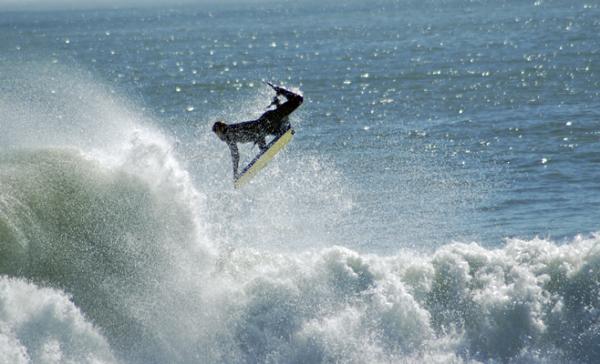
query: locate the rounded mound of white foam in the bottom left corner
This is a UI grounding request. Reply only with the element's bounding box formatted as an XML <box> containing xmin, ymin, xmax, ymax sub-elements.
<box><xmin>0</xmin><ymin>276</ymin><xmax>116</xmax><ymax>364</ymax></box>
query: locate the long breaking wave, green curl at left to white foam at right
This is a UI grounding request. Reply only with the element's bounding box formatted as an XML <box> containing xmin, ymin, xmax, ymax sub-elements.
<box><xmin>1</xmin><ymin>146</ymin><xmax>600</xmax><ymax>363</ymax></box>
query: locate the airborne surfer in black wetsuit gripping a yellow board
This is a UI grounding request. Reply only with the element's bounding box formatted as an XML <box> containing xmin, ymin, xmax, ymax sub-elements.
<box><xmin>212</xmin><ymin>82</ymin><xmax>304</xmax><ymax>180</ymax></box>
